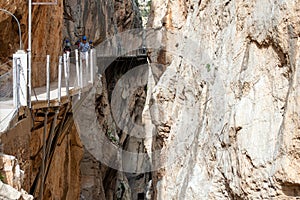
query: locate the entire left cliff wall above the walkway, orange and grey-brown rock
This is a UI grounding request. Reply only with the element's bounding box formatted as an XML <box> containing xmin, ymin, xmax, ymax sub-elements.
<box><xmin>0</xmin><ymin>0</ymin><xmax>141</xmax><ymax>87</ymax></box>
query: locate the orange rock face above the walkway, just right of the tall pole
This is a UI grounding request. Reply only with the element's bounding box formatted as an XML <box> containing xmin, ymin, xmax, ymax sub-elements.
<box><xmin>26</xmin><ymin>0</ymin><xmax>63</xmax><ymax>87</ymax></box>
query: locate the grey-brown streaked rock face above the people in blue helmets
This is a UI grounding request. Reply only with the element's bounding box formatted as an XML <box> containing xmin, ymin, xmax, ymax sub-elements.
<box><xmin>64</xmin><ymin>0</ymin><xmax>141</xmax><ymax>45</ymax></box>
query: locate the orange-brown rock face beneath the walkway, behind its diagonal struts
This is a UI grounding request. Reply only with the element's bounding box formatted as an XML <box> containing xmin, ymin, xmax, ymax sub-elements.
<box><xmin>29</xmin><ymin>108</ymin><xmax>83</xmax><ymax>199</ymax></box>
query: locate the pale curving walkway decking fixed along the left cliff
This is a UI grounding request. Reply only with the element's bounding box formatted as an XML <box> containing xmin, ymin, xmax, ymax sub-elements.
<box><xmin>0</xmin><ymin>50</ymin><xmax>147</xmax><ymax>133</ymax></box>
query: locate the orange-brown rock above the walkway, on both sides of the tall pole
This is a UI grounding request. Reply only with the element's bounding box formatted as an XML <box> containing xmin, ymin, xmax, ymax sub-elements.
<box><xmin>0</xmin><ymin>0</ymin><xmax>63</xmax><ymax>87</ymax></box>
